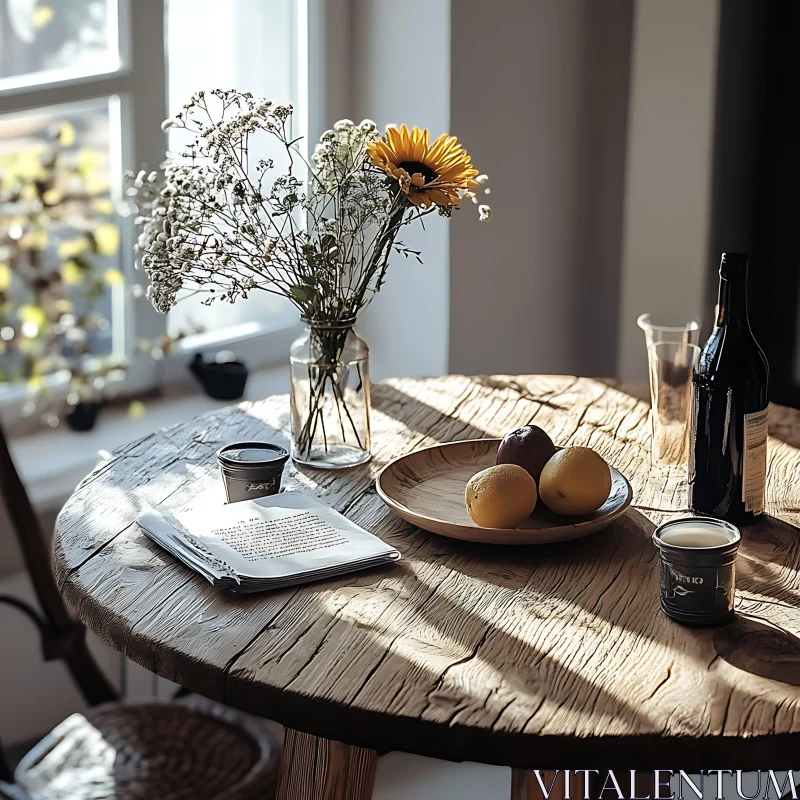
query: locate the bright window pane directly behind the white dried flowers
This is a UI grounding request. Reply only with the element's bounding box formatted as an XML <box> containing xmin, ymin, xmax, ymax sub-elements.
<box><xmin>167</xmin><ymin>0</ymin><xmax>297</xmax><ymax>335</ymax></box>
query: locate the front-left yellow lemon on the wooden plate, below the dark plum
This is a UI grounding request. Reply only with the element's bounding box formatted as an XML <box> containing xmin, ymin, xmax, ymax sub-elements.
<box><xmin>464</xmin><ymin>464</ymin><xmax>538</xmax><ymax>528</ymax></box>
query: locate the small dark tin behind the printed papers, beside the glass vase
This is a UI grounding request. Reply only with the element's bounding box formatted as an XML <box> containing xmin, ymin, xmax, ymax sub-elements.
<box><xmin>217</xmin><ymin>442</ymin><xmax>289</xmax><ymax>503</ymax></box>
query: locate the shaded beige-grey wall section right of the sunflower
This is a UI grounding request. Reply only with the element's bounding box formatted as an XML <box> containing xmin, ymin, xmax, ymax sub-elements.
<box><xmin>450</xmin><ymin>0</ymin><xmax>633</xmax><ymax>375</ymax></box>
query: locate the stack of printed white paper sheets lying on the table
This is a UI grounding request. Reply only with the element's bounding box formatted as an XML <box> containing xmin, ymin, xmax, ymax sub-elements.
<box><xmin>136</xmin><ymin>492</ymin><xmax>400</xmax><ymax>592</ymax></box>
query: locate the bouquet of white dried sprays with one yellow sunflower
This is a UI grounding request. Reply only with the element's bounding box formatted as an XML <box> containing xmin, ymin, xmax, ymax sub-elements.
<box><xmin>126</xmin><ymin>89</ymin><xmax>489</xmax><ymax>456</ymax></box>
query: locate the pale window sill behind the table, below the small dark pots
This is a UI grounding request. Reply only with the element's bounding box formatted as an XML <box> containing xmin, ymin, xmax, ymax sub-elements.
<box><xmin>9</xmin><ymin>365</ymin><xmax>289</xmax><ymax>512</ymax></box>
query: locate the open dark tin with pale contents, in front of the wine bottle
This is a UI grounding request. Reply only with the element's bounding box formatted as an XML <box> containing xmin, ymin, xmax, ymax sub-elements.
<box><xmin>653</xmin><ymin>517</ymin><xmax>742</xmax><ymax>625</ymax></box>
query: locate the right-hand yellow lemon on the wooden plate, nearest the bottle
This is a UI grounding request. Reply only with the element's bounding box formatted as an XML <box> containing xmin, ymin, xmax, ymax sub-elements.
<box><xmin>539</xmin><ymin>447</ymin><xmax>611</xmax><ymax>515</ymax></box>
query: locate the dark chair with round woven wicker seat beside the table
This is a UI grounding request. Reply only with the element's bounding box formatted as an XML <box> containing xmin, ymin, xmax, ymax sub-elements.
<box><xmin>0</xmin><ymin>428</ymin><xmax>279</xmax><ymax>800</ymax></box>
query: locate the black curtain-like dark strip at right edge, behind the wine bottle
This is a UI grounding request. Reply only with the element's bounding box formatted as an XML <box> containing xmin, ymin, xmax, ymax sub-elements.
<box><xmin>707</xmin><ymin>0</ymin><xmax>800</xmax><ymax>408</ymax></box>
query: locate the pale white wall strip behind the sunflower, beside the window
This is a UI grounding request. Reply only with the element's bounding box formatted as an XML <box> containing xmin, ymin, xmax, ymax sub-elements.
<box><xmin>351</xmin><ymin>0</ymin><xmax>450</xmax><ymax>380</ymax></box>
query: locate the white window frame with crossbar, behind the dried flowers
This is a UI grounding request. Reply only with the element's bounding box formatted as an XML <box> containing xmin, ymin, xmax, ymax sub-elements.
<box><xmin>0</xmin><ymin>0</ymin><xmax>310</xmax><ymax>418</ymax></box>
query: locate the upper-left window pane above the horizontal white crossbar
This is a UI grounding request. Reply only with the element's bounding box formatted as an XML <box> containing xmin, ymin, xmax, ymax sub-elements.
<box><xmin>0</xmin><ymin>0</ymin><xmax>119</xmax><ymax>89</ymax></box>
